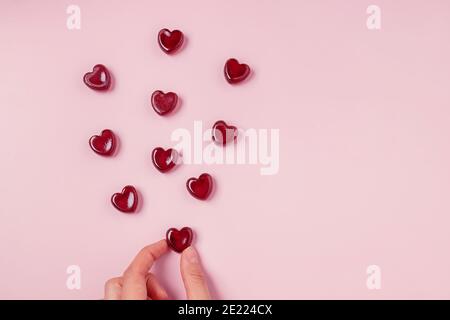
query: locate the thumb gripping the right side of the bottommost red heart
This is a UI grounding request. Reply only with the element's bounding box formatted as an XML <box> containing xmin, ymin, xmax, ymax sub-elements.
<box><xmin>180</xmin><ymin>247</ymin><xmax>211</xmax><ymax>300</ymax></box>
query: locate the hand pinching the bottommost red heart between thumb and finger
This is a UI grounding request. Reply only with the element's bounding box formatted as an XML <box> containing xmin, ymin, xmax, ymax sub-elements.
<box><xmin>105</xmin><ymin>240</ymin><xmax>211</xmax><ymax>300</ymax></box>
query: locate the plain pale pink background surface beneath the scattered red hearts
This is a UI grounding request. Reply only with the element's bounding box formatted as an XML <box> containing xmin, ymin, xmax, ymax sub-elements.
<box><xmin>0</xmin><ymin>0</ymin><xmax>450</xmax><ymax>299</ymax></box>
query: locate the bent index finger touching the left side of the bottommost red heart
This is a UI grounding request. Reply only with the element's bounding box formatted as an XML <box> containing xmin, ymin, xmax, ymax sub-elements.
<box><xmin>122</xmin><ymin>240</ymin><xmax>169</xmax><ymax>299</ymax></box>
